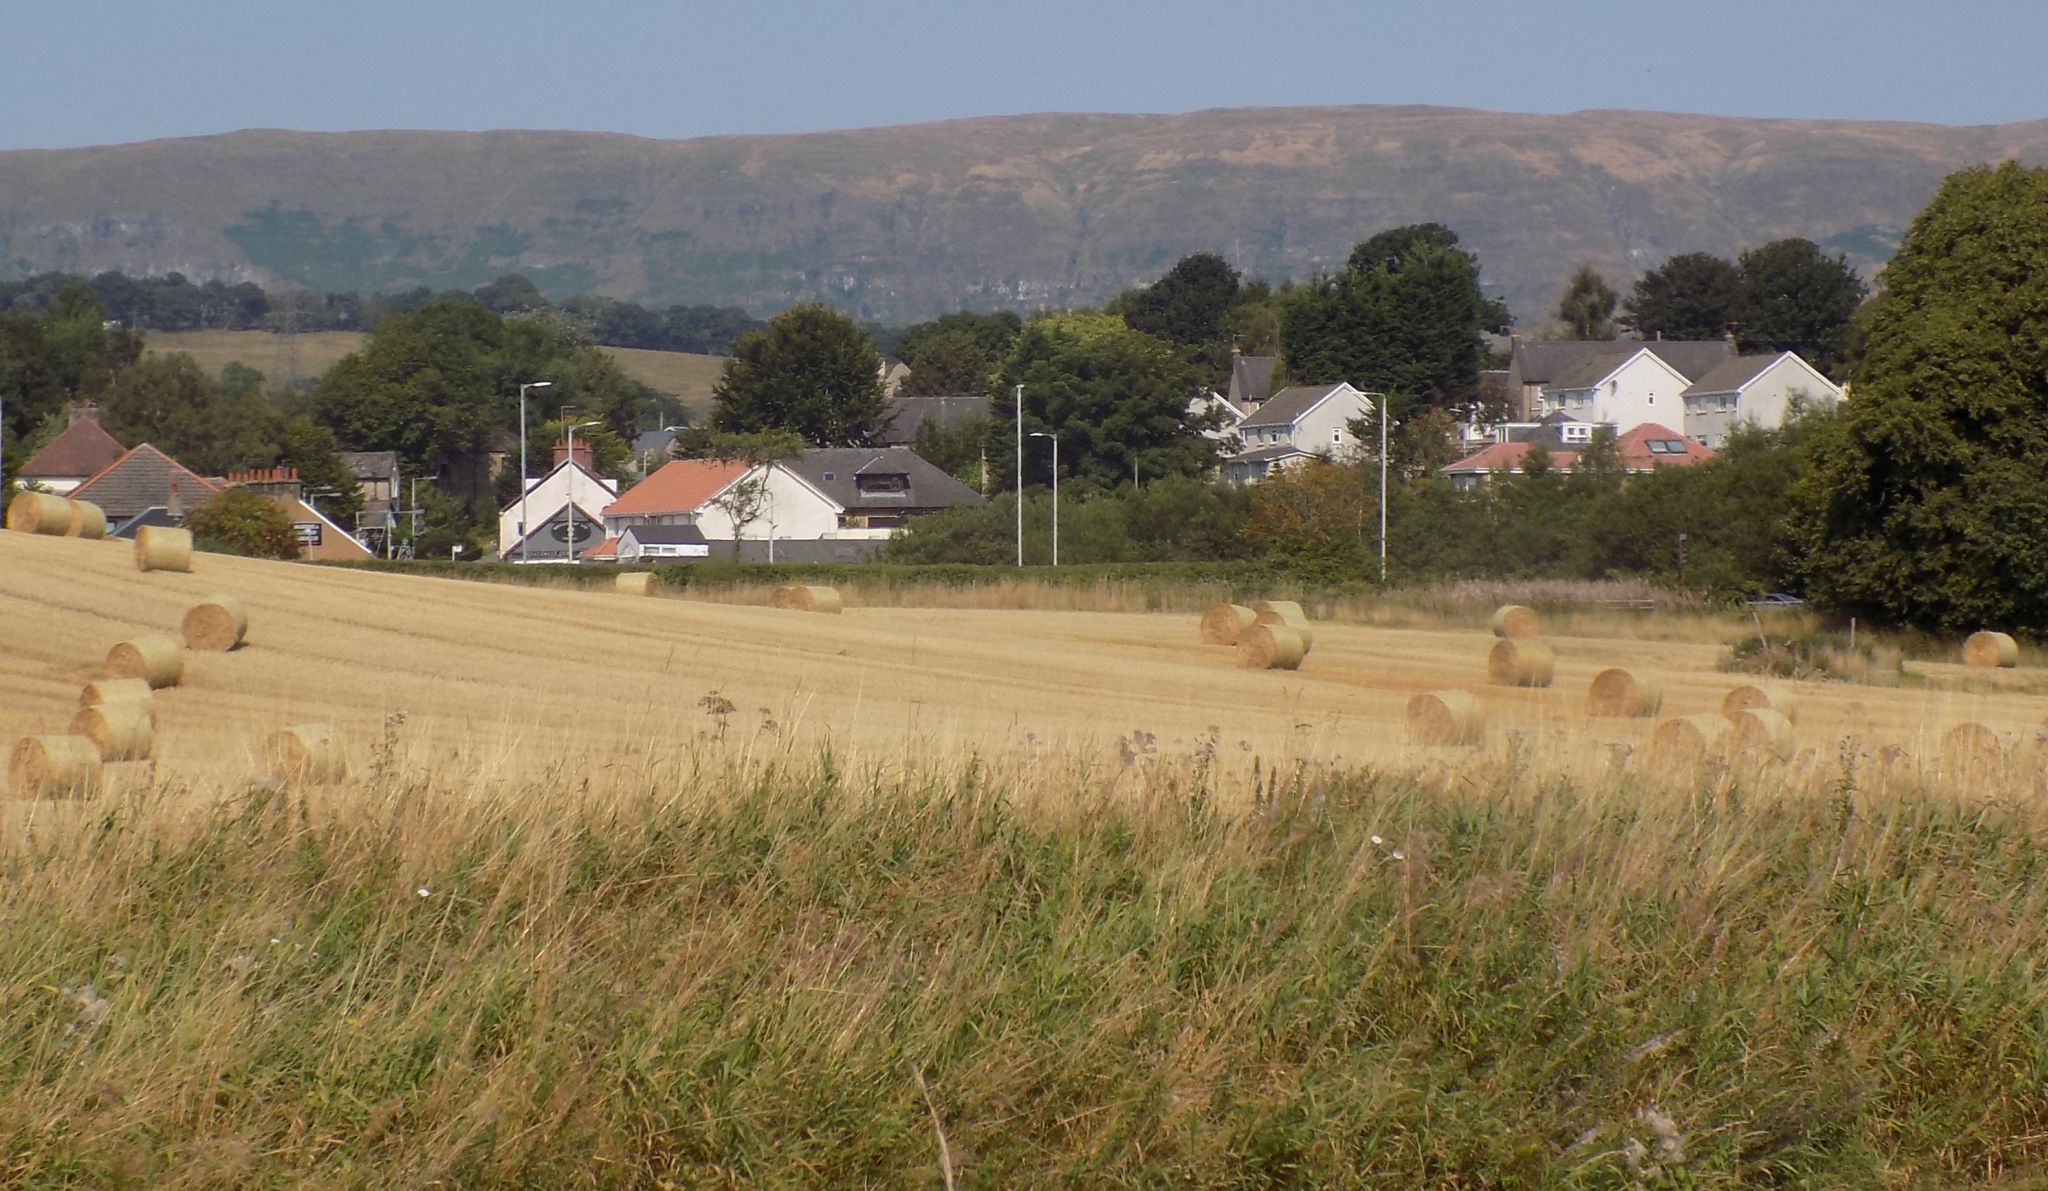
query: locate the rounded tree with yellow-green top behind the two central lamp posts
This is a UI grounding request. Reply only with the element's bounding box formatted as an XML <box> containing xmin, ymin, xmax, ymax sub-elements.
<box><xmin>989</xmin><ymin>311</ymin><xmax>1217</xmax><ymax>487</ymax></box>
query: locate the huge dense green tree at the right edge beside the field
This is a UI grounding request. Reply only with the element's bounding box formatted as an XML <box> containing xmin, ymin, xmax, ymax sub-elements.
<box><xmin>1794</xmin><ymin>164</ymin><xmax>2048</xmax><ymax>634</ymax></box>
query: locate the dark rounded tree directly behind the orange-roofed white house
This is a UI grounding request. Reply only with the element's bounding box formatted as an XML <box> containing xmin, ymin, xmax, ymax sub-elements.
<box><xmin>711</xmin><ymin>303</ymin><xmax>889</xmax><ymax>446</ymax></box>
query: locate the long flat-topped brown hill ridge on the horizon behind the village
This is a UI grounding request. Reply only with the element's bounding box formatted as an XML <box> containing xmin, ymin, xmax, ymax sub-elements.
<box><xmin>0</xmin><ymin>106</ymin><xmax>2048</xmax><ymax>325</ymax></box>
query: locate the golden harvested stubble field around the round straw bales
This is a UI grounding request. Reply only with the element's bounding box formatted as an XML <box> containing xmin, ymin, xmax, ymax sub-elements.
<box><xmin>0</xmin><ymin>534</ymin><xmax>2042</xmax><ymax>806</ymax></box>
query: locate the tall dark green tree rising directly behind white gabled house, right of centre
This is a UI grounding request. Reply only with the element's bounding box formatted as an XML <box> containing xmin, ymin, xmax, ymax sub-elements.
<box><xmin>1280</xmin><ymin>223</ymin><xmax>1507</xmax><ymax>413</ymax></box>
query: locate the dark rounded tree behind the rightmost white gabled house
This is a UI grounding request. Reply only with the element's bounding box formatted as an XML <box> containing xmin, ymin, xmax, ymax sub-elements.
<box><xmin>1735</xmin><ymin>239</ymin><xmax>1870</xmax><ymax>379</ymax></box>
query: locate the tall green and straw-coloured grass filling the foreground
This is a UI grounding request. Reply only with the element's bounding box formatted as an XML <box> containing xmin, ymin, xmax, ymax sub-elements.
<box><xmin>0</xmin><ymin>737</ymin><xmax>2048</xmax><ymax>1187</ymax></box>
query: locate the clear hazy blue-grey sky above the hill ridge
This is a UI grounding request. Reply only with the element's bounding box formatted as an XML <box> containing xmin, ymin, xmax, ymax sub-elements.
<box><xmin>0</xmin><ymin>0</ymin><xmax>2048</xmax><ymax>147</ymax></box>
